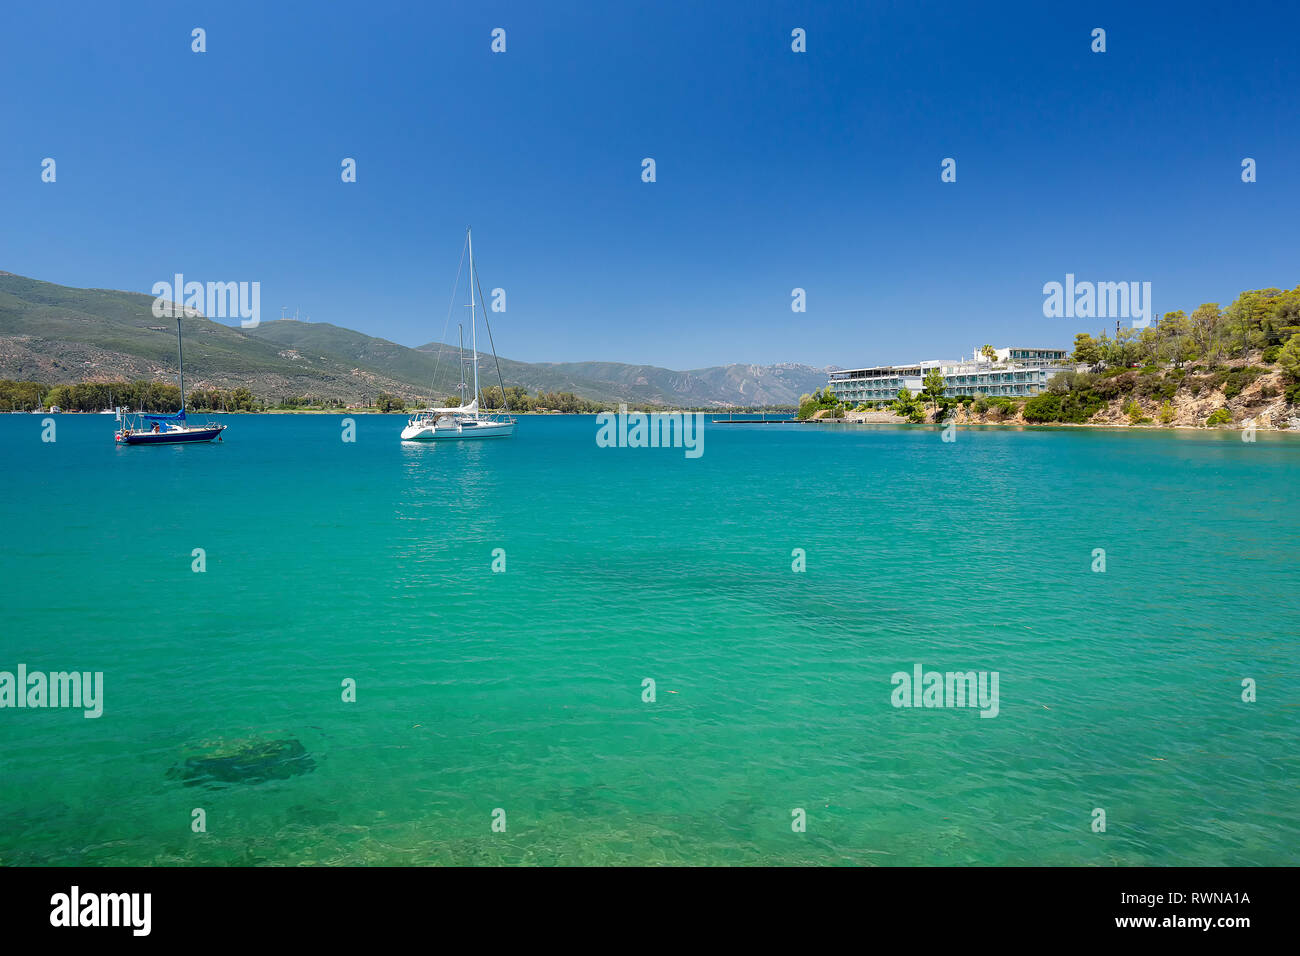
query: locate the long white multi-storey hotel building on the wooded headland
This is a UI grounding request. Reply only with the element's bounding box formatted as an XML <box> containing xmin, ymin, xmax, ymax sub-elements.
<box><xmin>827</xmin><ymin>349</ymin><xmax>1075</xmax><ymax>403</ymax></box>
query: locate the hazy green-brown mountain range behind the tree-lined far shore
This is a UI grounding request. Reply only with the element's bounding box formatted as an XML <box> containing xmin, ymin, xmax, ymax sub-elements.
<box><xmin>0</xmin><ymin>272</ymin><xmax>831</xmax><ymax>407</ymax></box>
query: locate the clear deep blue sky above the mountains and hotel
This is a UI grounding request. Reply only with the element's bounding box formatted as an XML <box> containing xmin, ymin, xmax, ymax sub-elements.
<box><xmin>0</xmin><ymin>0</ymin><xmax>1300</xmax><ymax>368</ymax></box>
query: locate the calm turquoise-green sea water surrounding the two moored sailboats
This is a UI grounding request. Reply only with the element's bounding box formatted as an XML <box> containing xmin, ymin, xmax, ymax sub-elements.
<box><xmin>0</xmin><ymin>415</ymin><xmax>1300</xmax><ymax>865</ymax></box>
